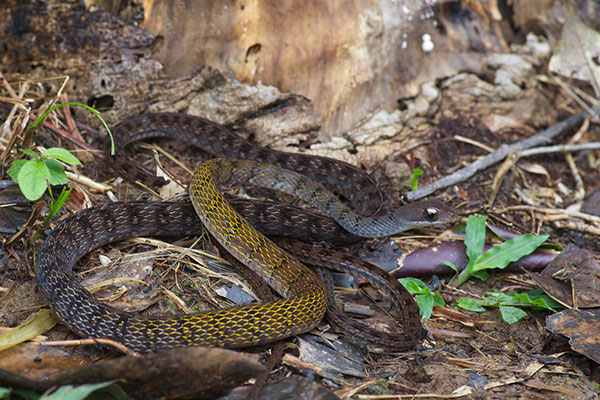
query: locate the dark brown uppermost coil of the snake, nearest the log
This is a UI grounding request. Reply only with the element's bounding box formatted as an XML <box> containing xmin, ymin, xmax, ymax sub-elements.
<box><xmin>110</xmin><ymin>113</ymin><xmax>388</xmax><ymax>216</ymax></box>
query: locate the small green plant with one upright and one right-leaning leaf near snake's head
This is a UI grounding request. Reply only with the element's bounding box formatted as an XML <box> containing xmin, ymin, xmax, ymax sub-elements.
<box><xmin>444</xmin><ymin>215</ymin><xmax>548</xmax><ymax>287</ymax></box>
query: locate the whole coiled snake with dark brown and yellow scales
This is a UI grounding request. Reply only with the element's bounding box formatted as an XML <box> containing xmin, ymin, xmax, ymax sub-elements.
<box><xmin>36</xmin><ymin>113</ymin><xmax>454</xmax><ymax>352</ymax></box>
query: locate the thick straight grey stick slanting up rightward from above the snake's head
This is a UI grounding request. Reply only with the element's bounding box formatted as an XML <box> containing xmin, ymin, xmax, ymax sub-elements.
<box><xmin>406</xmin><ymin>107</ymin><xmax>600</xmax><ymax>201</ymax></box>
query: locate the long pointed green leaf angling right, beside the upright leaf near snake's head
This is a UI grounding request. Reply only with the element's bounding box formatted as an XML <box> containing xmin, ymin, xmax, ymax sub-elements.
<box><xmin>473</xmin><ymin>233</ymin><xmax>548</xmax><ymax>272</ymax></box>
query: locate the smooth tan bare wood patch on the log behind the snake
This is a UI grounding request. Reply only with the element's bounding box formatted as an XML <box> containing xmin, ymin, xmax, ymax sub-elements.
<box><xmin>138</xmin><ymin>0</ymin><xmax>494</xmax><ymax>139</ymax></box>
